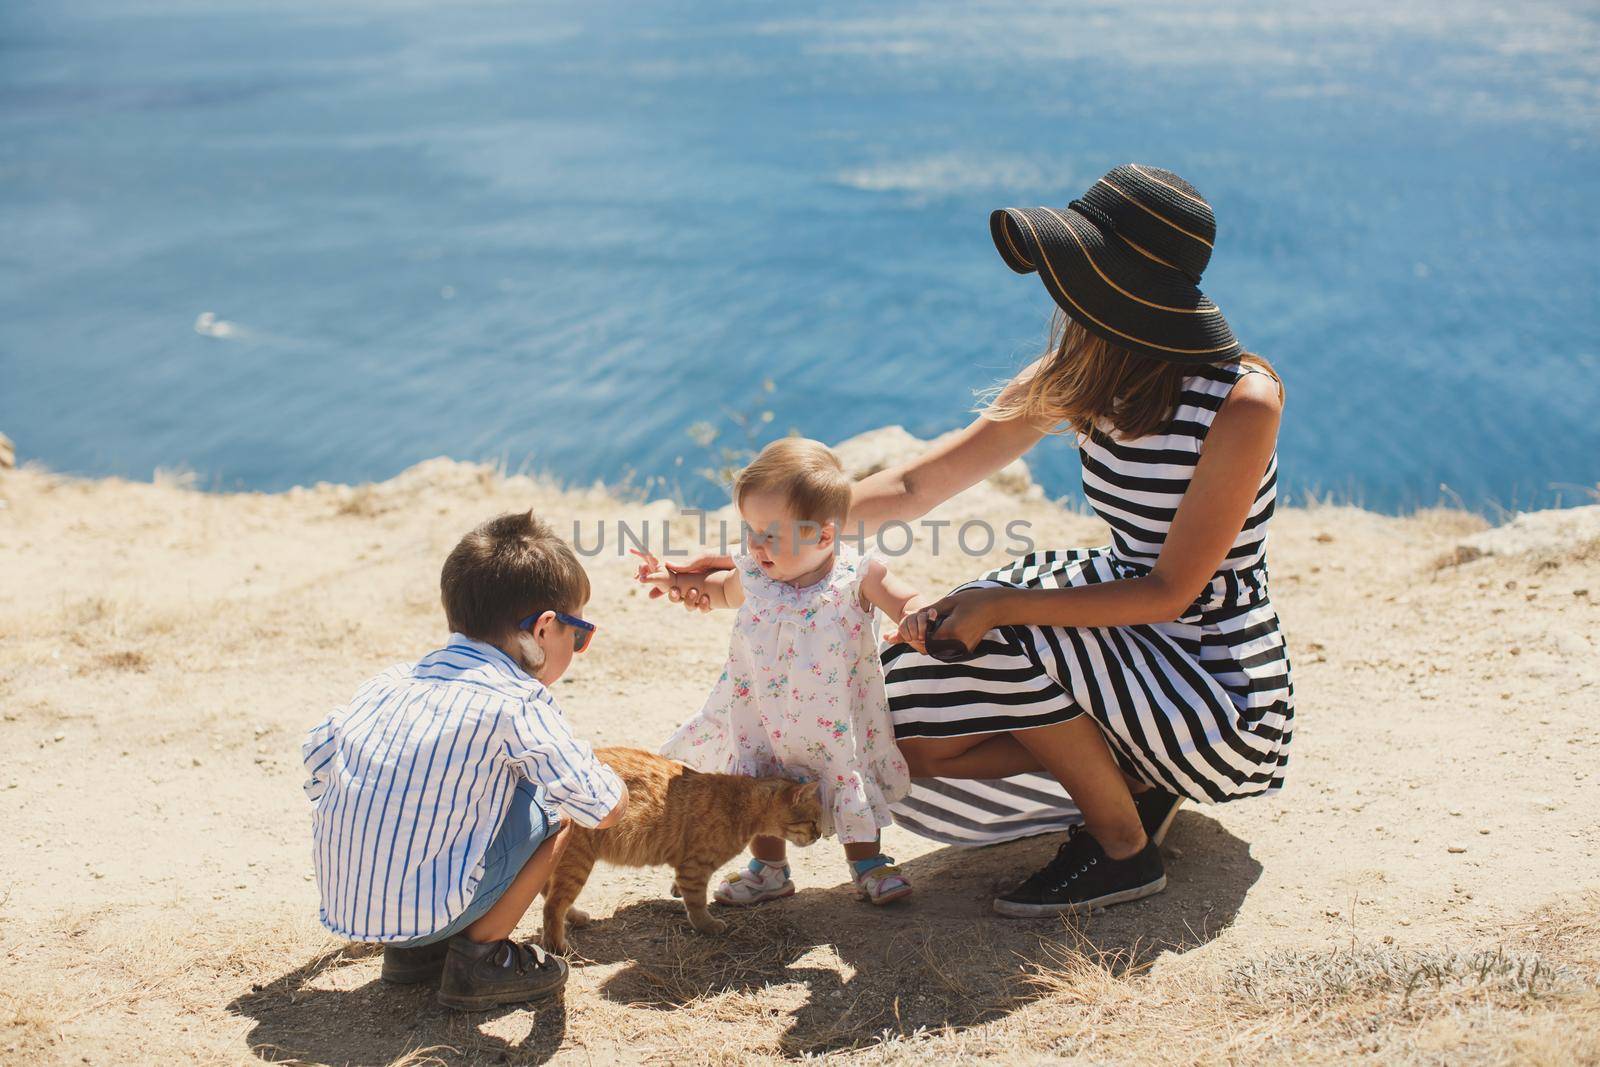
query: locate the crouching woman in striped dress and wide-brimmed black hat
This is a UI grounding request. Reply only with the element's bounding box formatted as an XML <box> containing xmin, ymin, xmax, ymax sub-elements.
<box><xmin>668</xmin><ymin>165</ymin><xmax>1293</xmax><ymax>917</ymax></box>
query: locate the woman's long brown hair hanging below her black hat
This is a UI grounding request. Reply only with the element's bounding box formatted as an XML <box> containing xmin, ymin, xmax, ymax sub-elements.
<box><xmin>981</xmin><ymin>309</ymin><xmax>1283</xmax><ymax>438</ymax></box>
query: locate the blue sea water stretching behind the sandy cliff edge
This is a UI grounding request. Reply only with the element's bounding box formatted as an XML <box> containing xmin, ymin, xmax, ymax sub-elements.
<box><xmin>0</xmin><ymin>0</ymin><xmax>1600</xmax><ymax>510</ymax></box>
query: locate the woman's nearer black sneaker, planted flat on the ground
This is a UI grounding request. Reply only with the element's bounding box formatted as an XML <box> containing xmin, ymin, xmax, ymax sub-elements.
<box><xmin>994</xmin><ymin>827</ymin><xmax>1166</xmax><ymax>918</ymax></box>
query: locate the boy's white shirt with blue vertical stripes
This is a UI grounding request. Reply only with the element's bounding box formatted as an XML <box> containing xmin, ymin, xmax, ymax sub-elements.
<box><xmin>301</xmin><ymin>633</ymin><xmax>622</xmax><ymax>941</ymax></box>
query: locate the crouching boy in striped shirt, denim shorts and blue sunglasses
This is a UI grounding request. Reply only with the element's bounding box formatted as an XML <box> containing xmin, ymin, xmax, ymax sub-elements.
<box><xmin>302</xmin><ymin>514</ymin><xmax>627</xmax><ymax>1009</ymax></box>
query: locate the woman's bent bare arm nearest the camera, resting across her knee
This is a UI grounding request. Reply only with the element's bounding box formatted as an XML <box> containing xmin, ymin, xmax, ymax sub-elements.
<box><xmin>901</xmin><ymin>374</ymin><xmax>1283</xmax><ymax>648</ymax></box>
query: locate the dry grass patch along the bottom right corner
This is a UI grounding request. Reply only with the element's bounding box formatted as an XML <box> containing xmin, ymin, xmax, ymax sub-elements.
<box><xmin>819</xmin><ymin>893</ymin><xmax>1600</xmax><ymax>1064</ymax></box>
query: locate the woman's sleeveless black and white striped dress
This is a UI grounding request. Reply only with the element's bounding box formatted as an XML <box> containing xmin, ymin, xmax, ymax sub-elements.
<box><xmin>882</xmin><ymin>362</ymin><xmax>1294</xmax><ymax>845</ymax></box>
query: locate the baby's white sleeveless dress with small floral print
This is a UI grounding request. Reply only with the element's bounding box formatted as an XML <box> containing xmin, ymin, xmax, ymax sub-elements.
<box><xmin>661</xmin><ymin>545</ymin><xmax>910</xmax><ymax>843</ymax></box>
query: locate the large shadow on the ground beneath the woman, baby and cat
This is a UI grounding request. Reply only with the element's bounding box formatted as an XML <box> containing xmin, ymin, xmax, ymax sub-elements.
<box><xmin>573</xmin><ymin>813</ymin><xmax>1261</xmax><ymax>1056</ymax></box>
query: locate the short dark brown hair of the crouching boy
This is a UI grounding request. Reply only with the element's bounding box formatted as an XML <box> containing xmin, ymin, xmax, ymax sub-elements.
<box><xmin>438</xmin><ymin>512</ymin><xmax>589</xmax><ymax>641</ymax></box>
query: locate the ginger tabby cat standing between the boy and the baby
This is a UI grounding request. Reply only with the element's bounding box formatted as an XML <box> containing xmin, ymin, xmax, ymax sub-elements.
<box><xmin>544</xmin><ymin>749</ymin><xmax>822</xmax><ymax>952</ymax></box>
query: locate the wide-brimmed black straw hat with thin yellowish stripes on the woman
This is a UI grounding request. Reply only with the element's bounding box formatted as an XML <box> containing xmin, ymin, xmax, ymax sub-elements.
<box><xmin>989</xmin><ymin>163</ymin><xmax>1240</xmax><ymax>363</ymax></box>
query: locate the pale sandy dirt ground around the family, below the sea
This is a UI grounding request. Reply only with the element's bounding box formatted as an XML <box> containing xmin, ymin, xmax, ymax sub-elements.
<box><xmin>0</xmin><ymin>461</ymin><xmax>1600</xmax><ymax>1064</ymax></box>
